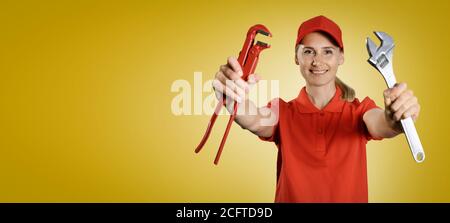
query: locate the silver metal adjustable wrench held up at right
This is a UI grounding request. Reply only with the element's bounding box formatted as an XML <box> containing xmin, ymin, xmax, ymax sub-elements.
<box><xmin>366</xmin><ymin>32</ymin><xmax>425</xmax><ymax>163</ymax></box>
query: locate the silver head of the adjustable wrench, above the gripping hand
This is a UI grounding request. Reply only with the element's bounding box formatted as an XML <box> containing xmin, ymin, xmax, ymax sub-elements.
<box><xmin>366</xmin><ymin>32</ymin><xmax>396</xmax><ymax>88</ymax></box>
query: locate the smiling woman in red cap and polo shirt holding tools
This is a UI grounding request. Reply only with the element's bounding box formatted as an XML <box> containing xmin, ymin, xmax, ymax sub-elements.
<box><xmin>213</xmin><ymin>16</ymin><xmax>420</xmax><ymax>202</ymax></box>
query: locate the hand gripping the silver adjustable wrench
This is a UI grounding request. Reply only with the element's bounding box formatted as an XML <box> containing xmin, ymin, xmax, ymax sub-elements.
<box><xmin>383</xmin><ymin>83</ymin><xmax>420</xmax><ymax>132</ymax></box>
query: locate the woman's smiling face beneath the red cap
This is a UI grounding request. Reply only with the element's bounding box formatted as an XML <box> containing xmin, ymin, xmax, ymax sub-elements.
<box><xmin>295</xmin><ymin>32</ymin><xmax>344</xmax><ymax>86</ymax></box>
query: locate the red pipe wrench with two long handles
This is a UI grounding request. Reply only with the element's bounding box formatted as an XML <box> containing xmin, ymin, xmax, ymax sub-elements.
<box><xmin>195</xmin><ymin>24</ymin><xmax>272</xmax><ymax>165</ymax></box>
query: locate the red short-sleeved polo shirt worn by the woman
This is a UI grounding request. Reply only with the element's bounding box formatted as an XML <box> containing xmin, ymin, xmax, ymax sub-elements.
<box><xmin>261</xmin><ymin>87</ymin><xmax>377</xmax><ymax>202</ymax></box>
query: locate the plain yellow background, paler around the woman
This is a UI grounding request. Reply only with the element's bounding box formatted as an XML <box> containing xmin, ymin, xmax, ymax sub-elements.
<box><xmin>0</xmin><ymin>0</ymin><xmax>450</xmax><ymax>202</ymax></box>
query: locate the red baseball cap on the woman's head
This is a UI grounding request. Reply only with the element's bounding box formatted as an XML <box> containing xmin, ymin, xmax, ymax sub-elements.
<box><xmin>295</xmin><ymin>15</ymin><xmax>344</xmax><ymax>50</ymax></box>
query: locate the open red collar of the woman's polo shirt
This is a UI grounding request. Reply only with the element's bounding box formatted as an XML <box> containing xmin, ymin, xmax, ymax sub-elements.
<box><xmin>295</xmin><ymin>86</ymin><xmax>345</xmax><ymax>113</ymax></box>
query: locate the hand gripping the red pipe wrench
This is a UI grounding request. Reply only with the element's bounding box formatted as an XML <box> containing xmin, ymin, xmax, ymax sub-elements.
<box><xmin>212</xmin><ymin>57</ymin><xmax>259</xmax><ymax>104</ymax></box>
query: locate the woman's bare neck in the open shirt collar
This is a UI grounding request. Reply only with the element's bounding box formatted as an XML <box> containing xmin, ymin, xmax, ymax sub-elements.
<box><xmin>306</xmin><ymin>81</ymin><xmax>336</xmax><ymax>110</ymax></box>
